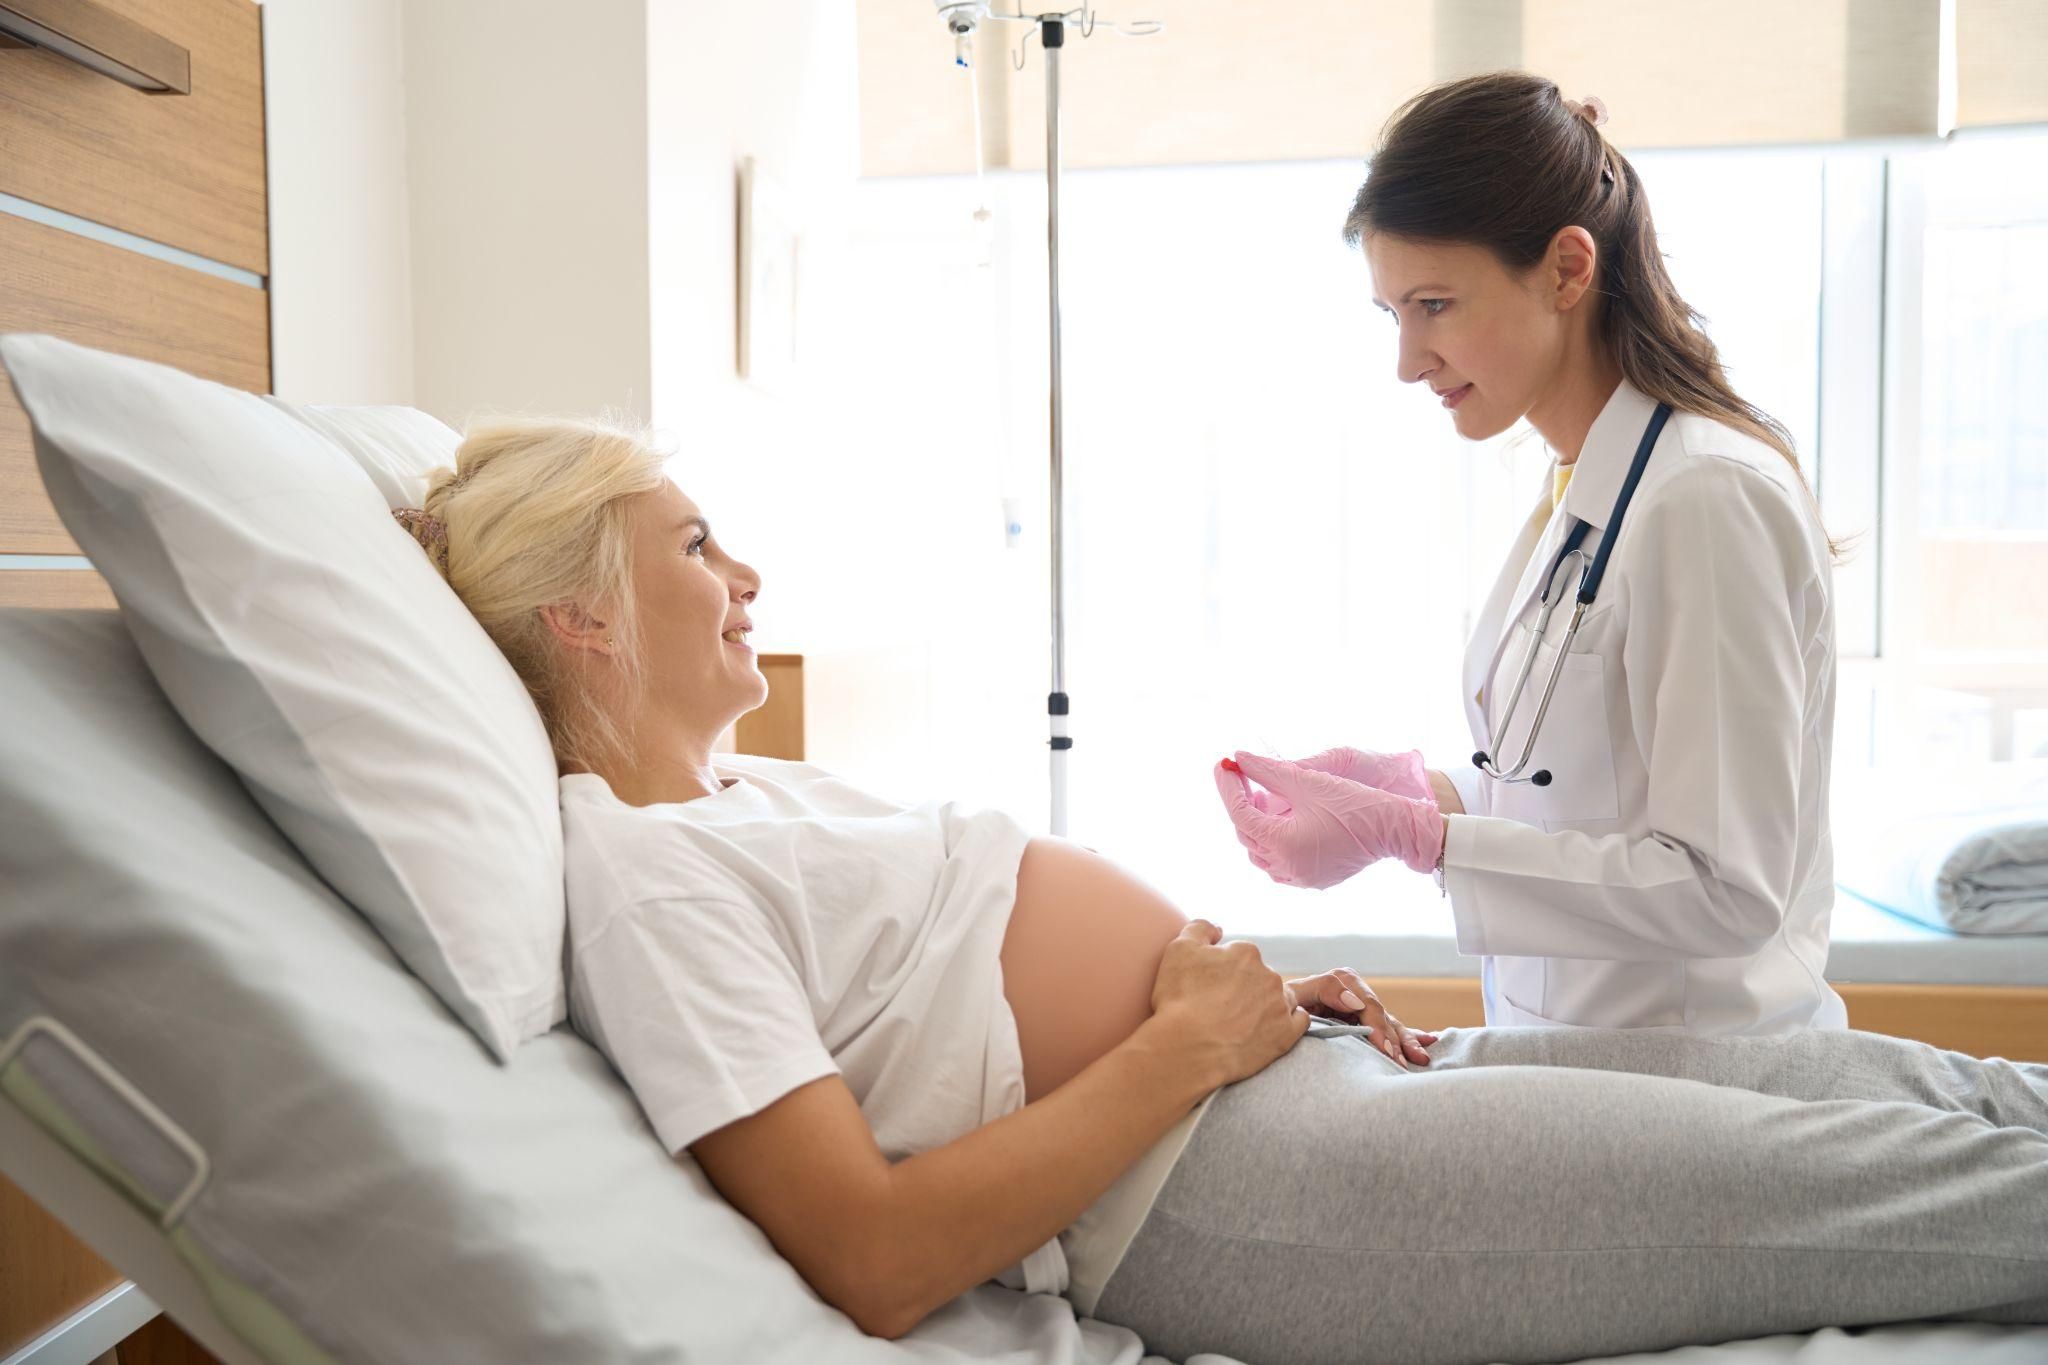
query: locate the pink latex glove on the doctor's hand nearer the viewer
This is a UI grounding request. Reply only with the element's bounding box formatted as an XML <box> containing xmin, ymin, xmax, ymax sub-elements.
<box><xmin>1217</xmin><ymin>753</ymin><xmax>1444</xmax><ymax>890</ymax></box>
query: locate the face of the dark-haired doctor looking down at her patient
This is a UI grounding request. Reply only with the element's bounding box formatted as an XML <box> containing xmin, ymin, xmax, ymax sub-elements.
<box><xmin>1364</xmin><ymin>233</ymin><xmax>1565</xmax><ymax>440</ymax></box>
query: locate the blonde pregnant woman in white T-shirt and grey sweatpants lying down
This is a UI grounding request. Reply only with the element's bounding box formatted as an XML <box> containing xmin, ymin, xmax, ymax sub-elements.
<box><xmin>401</xmin><ymin>424</ymin><xmax>2048</xmax><ymax>1363</ymax></box>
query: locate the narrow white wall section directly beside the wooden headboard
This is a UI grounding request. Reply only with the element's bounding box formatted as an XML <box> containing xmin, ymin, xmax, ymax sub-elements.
<box><xmin>262</xmin><ymin>0</ymin><xmax>414</xmax><ymax>403</ymax></box>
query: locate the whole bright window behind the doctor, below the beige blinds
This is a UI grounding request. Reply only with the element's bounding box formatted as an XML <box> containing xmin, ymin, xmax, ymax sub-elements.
<box><xmin>829</xmin><ymin>135</ymin><xmax>2048</xmax><ymax>931</ymax></box>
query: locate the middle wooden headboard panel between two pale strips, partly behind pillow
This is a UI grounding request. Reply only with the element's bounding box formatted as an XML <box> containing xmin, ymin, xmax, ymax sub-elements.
<box><xmin>0</xmin><ymin>213</ymin><xmax>270</xmax><ymax>555</ymax></box>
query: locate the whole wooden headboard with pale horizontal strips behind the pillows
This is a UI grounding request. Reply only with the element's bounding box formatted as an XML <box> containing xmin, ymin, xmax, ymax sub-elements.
<box><xmin>0</xmin><ymin>0</ymin><xmax>270</xmax><ymax>606</ymax></box>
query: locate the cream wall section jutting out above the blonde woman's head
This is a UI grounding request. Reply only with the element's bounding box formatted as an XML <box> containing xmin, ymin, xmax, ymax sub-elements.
<box><xmin>403</xmin><ymin>0</ymin><xmax>649</xmax><ymax>426</ymax></box>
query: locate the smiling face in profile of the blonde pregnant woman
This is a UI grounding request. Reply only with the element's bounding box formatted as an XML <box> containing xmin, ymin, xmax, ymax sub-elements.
<box><xmin>633</xmin><ymin>483</ymin><xmax>768</xmax><ymax>731</ymax></box>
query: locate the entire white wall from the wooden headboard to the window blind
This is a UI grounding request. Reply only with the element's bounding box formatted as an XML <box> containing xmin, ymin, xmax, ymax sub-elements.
<box><xmin>266</xmin><ymin>0</ymin><xmax>897</xmax><ymax>785</ymax></box>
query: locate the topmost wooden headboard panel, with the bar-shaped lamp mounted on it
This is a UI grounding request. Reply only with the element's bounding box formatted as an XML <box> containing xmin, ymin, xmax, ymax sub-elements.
<box><xmin>0</xmin><ymin>0</ymin><xmax>270</xmax><ymax>274</ymax></box>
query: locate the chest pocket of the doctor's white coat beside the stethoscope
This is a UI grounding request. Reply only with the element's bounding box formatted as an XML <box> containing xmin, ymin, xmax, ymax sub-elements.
<box><xmin>1493</xmin><ymin>624</ymin><xmax>1620</xmax><ymax>829</ymax></box>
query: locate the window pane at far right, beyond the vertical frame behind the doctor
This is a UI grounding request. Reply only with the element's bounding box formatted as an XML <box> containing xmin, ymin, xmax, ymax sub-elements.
<box><xmin>1867</xmin><ymin>131</ymin><xmax>2048</xmax><ymax>765</ymax></box>
